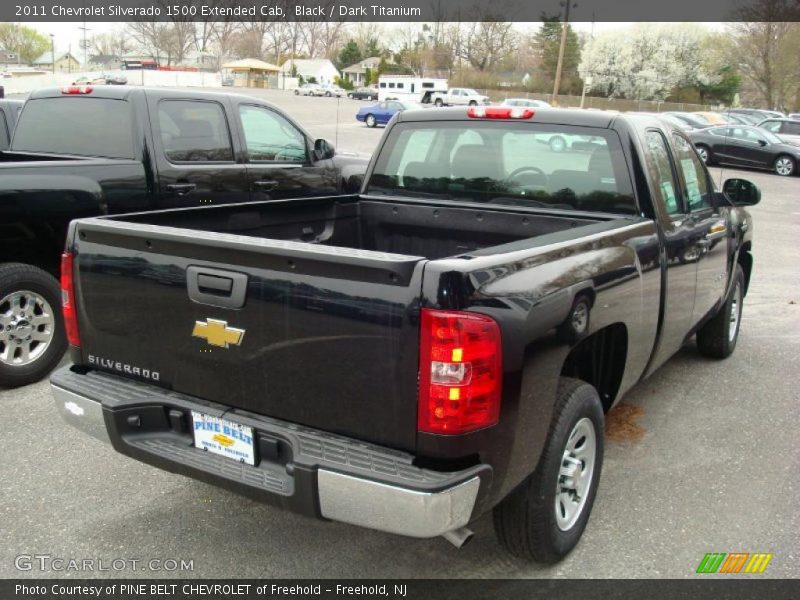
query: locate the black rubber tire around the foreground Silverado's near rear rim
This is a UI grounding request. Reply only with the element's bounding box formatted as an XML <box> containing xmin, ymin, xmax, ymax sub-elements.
<box><xmin>494</xmin><ymin>377</ymin><xmax>605</xmax><ymax>563</ymax></box>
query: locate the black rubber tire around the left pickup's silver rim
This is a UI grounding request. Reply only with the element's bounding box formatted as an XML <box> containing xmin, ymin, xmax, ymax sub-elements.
<box><xmin>0</xmin><ymin>263</ymin><xmax>67</xmax><ymax>387</ymax></box>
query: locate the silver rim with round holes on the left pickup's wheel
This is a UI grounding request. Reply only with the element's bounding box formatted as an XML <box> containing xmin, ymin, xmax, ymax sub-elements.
<box><xmin>0</xmin><ymin>290</ymin><xmax>56</xmax><ymax>367</ymax></box>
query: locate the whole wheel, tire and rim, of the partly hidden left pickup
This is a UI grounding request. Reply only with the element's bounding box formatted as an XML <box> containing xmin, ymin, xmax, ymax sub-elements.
<box><xmin>0</xmin><ymin>263</ymin><xmax>67</xmax><ymax>387</ymax></box>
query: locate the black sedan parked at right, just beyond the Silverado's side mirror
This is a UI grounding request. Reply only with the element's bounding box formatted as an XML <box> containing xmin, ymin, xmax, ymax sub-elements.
<box><xmin>689</xmin><ymin>125</ymin><xmax>800</xmax><ymax>176</ymax></box>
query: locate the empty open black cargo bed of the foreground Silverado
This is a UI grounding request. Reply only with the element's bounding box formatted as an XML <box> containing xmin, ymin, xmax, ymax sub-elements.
<box><xmin>115</xmin><ymin>196</ymin><xmax>610</xmax><ymax>260</ymax></box>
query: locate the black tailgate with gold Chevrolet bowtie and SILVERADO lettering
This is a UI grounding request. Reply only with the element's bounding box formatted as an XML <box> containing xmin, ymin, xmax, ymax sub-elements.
<box><xmin>74</xmin><ymin>219</ymin><xmax>425</xmax><ymax>450</ymax></box>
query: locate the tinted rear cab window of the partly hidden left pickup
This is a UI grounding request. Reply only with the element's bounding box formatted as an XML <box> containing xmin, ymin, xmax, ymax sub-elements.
<box><xmin>11</xmin><ymin>96</ymin><xmax>134</xmax><ymax>158</ymax></box>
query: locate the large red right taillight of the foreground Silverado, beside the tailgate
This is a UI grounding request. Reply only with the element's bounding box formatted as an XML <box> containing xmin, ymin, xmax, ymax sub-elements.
<box><xmin>417</xmin><ymin>308</ymin><xmax>503</xmax><ymax>435</ymax></box>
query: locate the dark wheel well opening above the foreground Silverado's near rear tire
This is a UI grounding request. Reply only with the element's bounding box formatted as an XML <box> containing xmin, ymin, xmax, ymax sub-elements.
<box><xmin>561</xmin><ymin>323</ymin><xmax>628</xmax><ymax>411</ymax></box>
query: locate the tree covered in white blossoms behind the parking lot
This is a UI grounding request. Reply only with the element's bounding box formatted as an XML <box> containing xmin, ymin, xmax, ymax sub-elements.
<box><xmin>578</xmin><ymin>23</ymin><xmax>711</xmax><ymax>100</ymax></box>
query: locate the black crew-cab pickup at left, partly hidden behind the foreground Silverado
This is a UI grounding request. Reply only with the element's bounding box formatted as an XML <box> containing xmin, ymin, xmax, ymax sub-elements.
<box><xmin>0</xmin><ymin>86</ymin><xmax>368</xmax><ymax>386</ymax></box>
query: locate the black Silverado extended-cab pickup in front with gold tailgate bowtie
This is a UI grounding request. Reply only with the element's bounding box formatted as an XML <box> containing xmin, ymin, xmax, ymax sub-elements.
<box><xmin>51</xmin><ymin>107</ymin><xmax>760</xmax><ymax>561</ymax></box>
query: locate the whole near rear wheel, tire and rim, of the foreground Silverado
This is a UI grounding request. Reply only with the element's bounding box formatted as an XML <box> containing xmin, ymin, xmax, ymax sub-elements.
<box><xmin>494</xmin><ymin>377</ymin><xmax>604</xmax><ymax>563</ymax></box>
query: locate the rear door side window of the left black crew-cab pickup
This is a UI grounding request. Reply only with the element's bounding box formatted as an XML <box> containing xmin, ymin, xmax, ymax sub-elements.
<box><xmin>158</xmin><ymin>100</ymin><xmax>233</xmax><ymax>162</ymax></box>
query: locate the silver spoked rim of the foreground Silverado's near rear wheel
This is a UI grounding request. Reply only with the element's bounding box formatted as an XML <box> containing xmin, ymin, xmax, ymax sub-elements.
<box><xmin>554</xmin><ymin>417</ymin><xmax>597</xmax><ymax>531</ymax></box>
